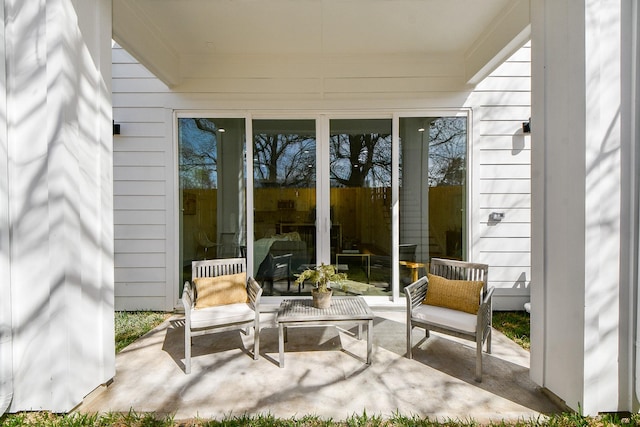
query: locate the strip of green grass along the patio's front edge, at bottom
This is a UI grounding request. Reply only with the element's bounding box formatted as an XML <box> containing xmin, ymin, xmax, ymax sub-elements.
<box><xmin>0</xmin><ymin>411</ymin><xmax>640</xmax><ymax>427</ymax></box>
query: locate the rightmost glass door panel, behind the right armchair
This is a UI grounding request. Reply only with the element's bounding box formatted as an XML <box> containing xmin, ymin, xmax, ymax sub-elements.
<box><xmin>399</xmin><ymin>117</ymin><xmax>467</xmax><ymax>292</ymax></box>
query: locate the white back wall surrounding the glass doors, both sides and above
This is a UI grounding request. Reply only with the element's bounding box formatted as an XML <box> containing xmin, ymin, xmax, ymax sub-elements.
<box><xmin>113</xmin><ymin>42</ymin><xmax>530</xmax><ymax>310</ymax></box>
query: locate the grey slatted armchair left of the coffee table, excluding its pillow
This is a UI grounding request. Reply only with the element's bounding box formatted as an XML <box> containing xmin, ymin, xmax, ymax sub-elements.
<box><xmin>182</xmin><ymin>258</ymin><xmax>262</xmax><ymax>374</ymax></box>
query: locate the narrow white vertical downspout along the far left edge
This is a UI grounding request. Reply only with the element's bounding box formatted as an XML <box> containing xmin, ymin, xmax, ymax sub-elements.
<box><xmin>0</xmin><ymin>0</ymin><xmax>13</xmax><ymax>416</ymax></box>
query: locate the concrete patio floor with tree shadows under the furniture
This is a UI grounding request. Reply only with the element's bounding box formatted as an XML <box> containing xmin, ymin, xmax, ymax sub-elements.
<box><xmin>77</xmin><ymin>307</ymin><xmax>562</xmax><ymax>422</ymax></box>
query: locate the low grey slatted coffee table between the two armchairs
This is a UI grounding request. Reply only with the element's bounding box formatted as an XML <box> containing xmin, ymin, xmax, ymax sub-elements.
<box><xmin>276</xmin><ymin>296</ymin><xmax>373</xmax><ymax>368</ymax></box>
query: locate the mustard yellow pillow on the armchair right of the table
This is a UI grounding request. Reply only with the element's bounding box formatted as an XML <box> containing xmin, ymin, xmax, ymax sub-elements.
<box><xmin>423</xmin><ymin>274</ymin><xmax>484</xmax><ymax>314</ymax></box>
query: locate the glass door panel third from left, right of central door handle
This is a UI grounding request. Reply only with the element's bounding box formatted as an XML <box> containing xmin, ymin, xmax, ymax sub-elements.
<box><xmin>329</xmin><ymin>119</ymin><xmax>392</xmax><ymax>295</ymax></box>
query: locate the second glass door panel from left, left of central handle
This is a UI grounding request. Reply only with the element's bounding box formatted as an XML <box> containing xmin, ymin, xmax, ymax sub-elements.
<box><xmin>253</xmin><ymin>120</ymin><xmax>316</xmax><ymax>295</ymax></box>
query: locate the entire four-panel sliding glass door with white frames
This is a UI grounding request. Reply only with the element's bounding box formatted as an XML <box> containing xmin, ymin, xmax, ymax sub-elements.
<box><xmin>178</xmin><ymin>115</ymin><xmax>468</xmax><ymax>296</ymax></box>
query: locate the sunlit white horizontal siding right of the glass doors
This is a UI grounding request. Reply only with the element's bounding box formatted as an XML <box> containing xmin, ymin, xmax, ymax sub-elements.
<box><xmin>470</xmin><ymin>45</ymin><xmax>531</xmax><ymax>310</ymax></box>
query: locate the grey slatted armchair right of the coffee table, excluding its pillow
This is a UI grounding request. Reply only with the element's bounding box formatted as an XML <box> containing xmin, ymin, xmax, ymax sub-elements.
<box><xmin>405</xmin><ymin>258</ymin><xmax>493</xmax><ymax>382</ymax></box>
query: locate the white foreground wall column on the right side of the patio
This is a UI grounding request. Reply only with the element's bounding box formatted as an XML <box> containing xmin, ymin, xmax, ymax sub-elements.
<box><xmin>531</xmin><ymin>0</ymin><xmax>638</xmax><ymax>414</ymax></box>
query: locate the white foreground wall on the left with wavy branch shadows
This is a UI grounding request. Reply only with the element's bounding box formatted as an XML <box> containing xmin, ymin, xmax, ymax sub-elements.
<box><xmin>0</xmin><ymin>0</ymin><xmax>115</xmax><ymax>412</ymax></box>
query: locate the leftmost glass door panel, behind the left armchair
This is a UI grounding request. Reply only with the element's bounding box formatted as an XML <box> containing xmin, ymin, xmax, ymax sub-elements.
<box><xmin>178</xmin><ymin>117</ymin><xmax>246</xmax><ymax>291</ymax></box>
